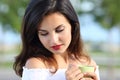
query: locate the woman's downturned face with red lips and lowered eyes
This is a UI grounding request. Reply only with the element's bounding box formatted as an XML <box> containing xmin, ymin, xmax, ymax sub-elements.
<box><xmin>38</xmin><ymin>13</ymin><xmax>71</xmax><ymax>54</ymax></box>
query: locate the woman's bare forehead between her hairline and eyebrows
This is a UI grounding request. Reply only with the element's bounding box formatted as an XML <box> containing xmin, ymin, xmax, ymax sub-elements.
<box><xmin>39</xmin><ymin>12</ymin><xmax>69</xmax><ymax>29</ymax></box>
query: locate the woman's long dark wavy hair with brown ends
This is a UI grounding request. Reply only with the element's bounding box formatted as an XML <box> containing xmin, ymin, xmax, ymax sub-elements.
<box><xmin>13</xmin><ymin>0</ymin><xmax>89</xmax><ymax>76</ymax></box>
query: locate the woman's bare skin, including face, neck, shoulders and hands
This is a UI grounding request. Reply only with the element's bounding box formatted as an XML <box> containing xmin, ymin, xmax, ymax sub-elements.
<box><xmin>25</xmin><ymin>13</ymin><xmax>97</xmax><ymax>80</ymax></box>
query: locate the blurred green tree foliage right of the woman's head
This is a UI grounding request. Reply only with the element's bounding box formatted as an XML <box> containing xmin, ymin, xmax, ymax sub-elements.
<box><xmin>77</xmin><ymin>0</ymin><xmax>120</xmax><ymax>30</ymax></box>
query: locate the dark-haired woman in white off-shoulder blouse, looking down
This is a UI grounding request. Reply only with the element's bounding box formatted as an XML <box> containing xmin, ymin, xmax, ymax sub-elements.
<box><xmin>14</xmin><ymin>0</ymin><xmax>99</xmax><ymax>80</ymax></box>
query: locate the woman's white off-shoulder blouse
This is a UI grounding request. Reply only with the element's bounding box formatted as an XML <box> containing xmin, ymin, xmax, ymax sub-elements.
<box><xmin>22</xmin><ymin>67</ymin><xmax>100</xmax><ymax>80</ymax></box>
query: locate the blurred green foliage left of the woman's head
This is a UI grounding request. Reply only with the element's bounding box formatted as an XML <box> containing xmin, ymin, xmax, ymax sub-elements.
<box><xmin>0</xmin><ymin>0</ymin><xmax>28</xmax><ymax>32</ymax></box>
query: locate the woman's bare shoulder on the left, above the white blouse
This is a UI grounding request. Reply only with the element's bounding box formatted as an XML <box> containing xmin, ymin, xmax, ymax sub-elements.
<box><xmin>25</xmin><ymin>58</ymin><xmax>46</xmax><ymax>69</ymax></box>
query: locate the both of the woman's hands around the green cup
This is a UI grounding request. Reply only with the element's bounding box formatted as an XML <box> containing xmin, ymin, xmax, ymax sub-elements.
<box><xmin>66</xmin><ymin>60</ymin><xmax>98</xmax><ymax>80</ymax></box>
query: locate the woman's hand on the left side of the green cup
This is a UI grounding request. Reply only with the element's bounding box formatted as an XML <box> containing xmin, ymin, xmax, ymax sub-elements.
<box><xmin>65</xmin><ymin>64</ymin><xmax>84</xmax><ymax>80</ymax></box>
